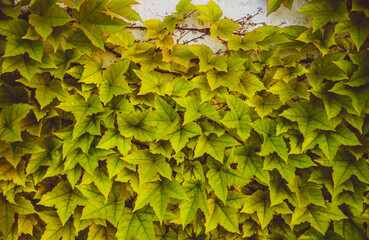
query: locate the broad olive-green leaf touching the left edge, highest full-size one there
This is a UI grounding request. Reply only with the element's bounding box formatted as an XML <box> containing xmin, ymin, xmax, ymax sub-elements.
<box><xmin>0</xmin><ymin>19</ymin><xmax>43</xmax><ymax>62</ymax></box>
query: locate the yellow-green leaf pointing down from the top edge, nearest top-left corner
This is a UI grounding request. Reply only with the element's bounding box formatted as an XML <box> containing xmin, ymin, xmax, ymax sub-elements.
<box><xmin>29</xmin><ymin>0</ymin><xmax>72</xmax><ymax>40</ymax></box>
